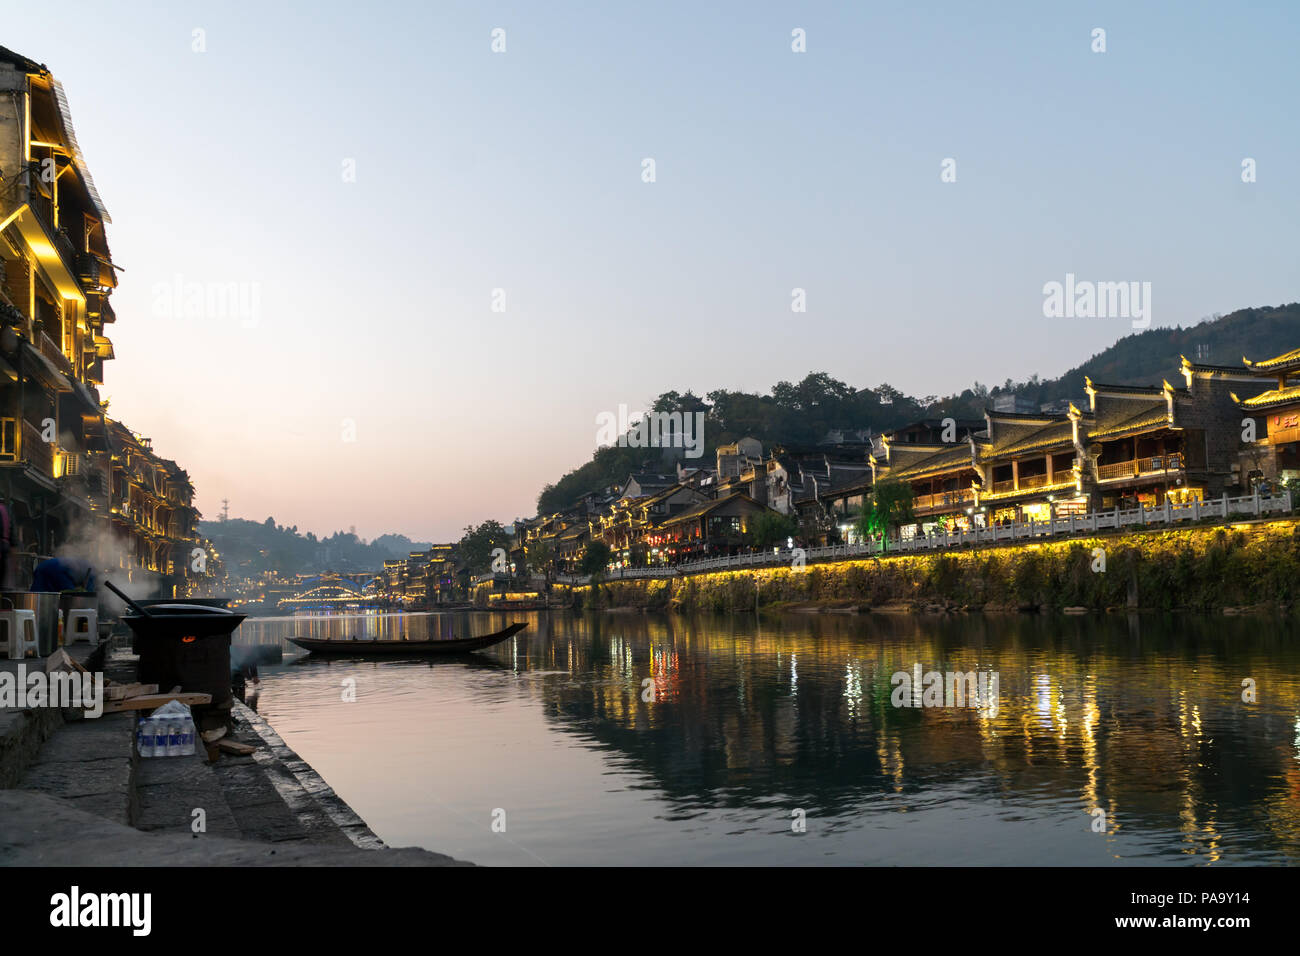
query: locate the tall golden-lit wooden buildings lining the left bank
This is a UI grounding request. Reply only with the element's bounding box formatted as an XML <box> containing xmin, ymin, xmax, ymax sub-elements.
<box><xmin>0</xmin><ymin>47</ymin><xmax>200</xmax><ymax>597</ymax></box>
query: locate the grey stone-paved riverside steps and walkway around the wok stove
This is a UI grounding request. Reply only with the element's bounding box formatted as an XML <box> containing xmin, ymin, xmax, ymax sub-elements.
<box><xmin>0</xmin><ymin>645</ymin><xmax>469</xmax><ymax>866</ymax></box>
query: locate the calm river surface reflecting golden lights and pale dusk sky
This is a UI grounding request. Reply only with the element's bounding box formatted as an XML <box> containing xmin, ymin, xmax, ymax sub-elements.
<box><xmin>237</xmin><ymin>614</ymin><xmax>1300</xmax><ymax>865</ymax></box>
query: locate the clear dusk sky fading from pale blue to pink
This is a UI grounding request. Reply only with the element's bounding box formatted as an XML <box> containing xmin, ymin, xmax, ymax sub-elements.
<box><xmin>0</xmin><ymin>0</ymin><xmax>1300</xmax><ymax>541</ymax></box>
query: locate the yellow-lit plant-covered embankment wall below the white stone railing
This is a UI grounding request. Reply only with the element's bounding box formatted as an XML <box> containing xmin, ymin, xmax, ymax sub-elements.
<box><xmin>571</xmin><ymin>519</ymin><xmax>1300</xmax><ymax>611</ymax></box>
